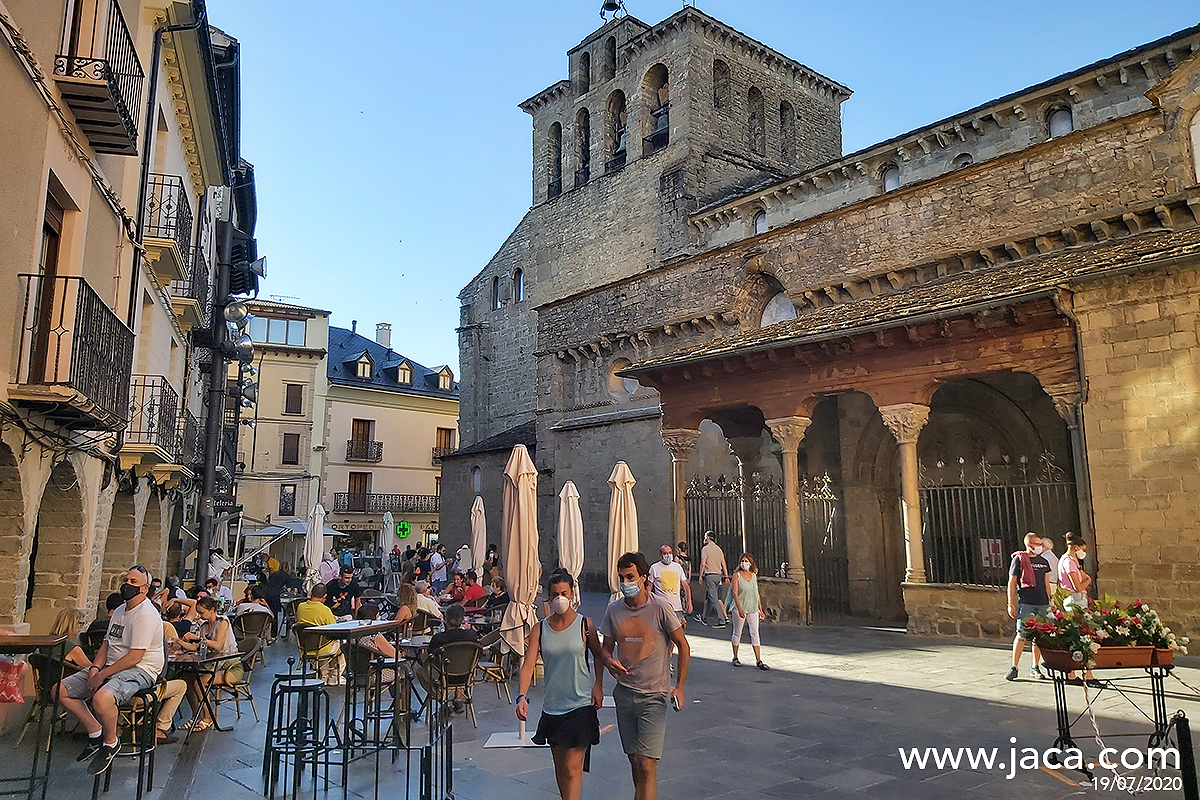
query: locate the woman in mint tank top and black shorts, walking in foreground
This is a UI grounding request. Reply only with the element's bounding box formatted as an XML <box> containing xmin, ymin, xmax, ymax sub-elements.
<box><xmin>516</xmin><ymin>570</ymin><xmax>625</xmax><ymax>800</ymax></box>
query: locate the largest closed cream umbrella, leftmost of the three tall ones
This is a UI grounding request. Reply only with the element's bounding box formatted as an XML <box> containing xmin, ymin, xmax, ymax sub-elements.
<box><xmin>500</xmin><ymin>445</ymin><xmax>541</xmax><ymax>655</ymax></box>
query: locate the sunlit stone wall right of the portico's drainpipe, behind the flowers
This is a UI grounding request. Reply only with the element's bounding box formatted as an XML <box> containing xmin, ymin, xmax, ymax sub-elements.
<box><xmin>1074</xmin><ymin>268</ymin><xmax>1200</xmax><ymax>637</ymax></box>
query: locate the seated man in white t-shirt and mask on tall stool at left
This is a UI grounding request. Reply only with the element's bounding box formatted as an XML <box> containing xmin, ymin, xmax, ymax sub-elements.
<box><xmin>59</xmin><ymin>566</ymin><xmax>166</xmax><ymax>775</ymax></box>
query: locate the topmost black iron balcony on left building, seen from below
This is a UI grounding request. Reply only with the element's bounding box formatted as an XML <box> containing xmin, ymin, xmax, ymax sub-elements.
<box><xmin>54</xmin><ymin>0</ymin><xmax>144</xmax><ymax>156</ymax></box>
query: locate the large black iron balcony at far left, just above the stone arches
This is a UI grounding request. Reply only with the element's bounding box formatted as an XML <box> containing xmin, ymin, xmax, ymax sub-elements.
<box><xmin>8</xmin><ymin>275</ymin><xmax>133</xmax><ymax>431</ymax></box>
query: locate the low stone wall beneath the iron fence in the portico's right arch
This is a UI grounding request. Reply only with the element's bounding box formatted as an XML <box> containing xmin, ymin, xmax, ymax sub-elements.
<box><xmin>902</xmin><ymin>583</ymin><xmax>1014</xmax><ymax>639</ymax></box>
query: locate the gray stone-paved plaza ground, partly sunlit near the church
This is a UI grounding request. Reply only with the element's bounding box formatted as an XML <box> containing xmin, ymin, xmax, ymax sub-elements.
<box><xmin>21</xmin><ymin>596</ymin><xmax>1200</xmax><ymax>800</ymax></box>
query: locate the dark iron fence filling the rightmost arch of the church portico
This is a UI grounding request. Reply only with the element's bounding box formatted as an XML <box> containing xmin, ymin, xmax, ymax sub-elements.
<box><xmin>920</xmin><ymin>452</ymin><xmax>1079</xmax><ymax>587</ymax></box>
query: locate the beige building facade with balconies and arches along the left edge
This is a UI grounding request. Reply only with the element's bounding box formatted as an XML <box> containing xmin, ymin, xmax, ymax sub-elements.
<box><xmin>0</xmin><ymin>0</ymin><xmax>253</xmax><ymax>631</ymax></box>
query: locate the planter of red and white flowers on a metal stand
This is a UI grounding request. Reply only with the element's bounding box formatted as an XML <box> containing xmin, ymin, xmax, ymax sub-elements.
<box><xmin>1021</xmin><ymin>590</ymin><xmax>1188</xmax><ymax>672</ymax></box>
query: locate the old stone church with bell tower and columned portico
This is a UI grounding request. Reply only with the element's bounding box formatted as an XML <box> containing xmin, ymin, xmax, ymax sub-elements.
<box><xmin>443</xmin><ymin>8</ymin><xmax>1200</xmax><ymax>636</ymax></box>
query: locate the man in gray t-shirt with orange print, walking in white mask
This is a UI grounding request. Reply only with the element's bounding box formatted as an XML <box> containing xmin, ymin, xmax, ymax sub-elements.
<box><xmin>596</xmin><ymin>553</ymin><xmax>691</xmax><ymax>796</ymax></box>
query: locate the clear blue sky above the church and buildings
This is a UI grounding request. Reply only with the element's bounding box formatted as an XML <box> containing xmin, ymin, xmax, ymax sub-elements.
<box><xmin>208</xmin><ymin>0</ymin><xmax>1200</xmax><ymax>373</ymax></box>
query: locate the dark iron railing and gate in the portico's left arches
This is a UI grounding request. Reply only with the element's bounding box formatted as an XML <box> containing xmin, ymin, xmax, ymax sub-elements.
<box><xmin>686</xmin><ymin>474</ymin><xmax>850</xmax><ymax>620</ymax></box>
